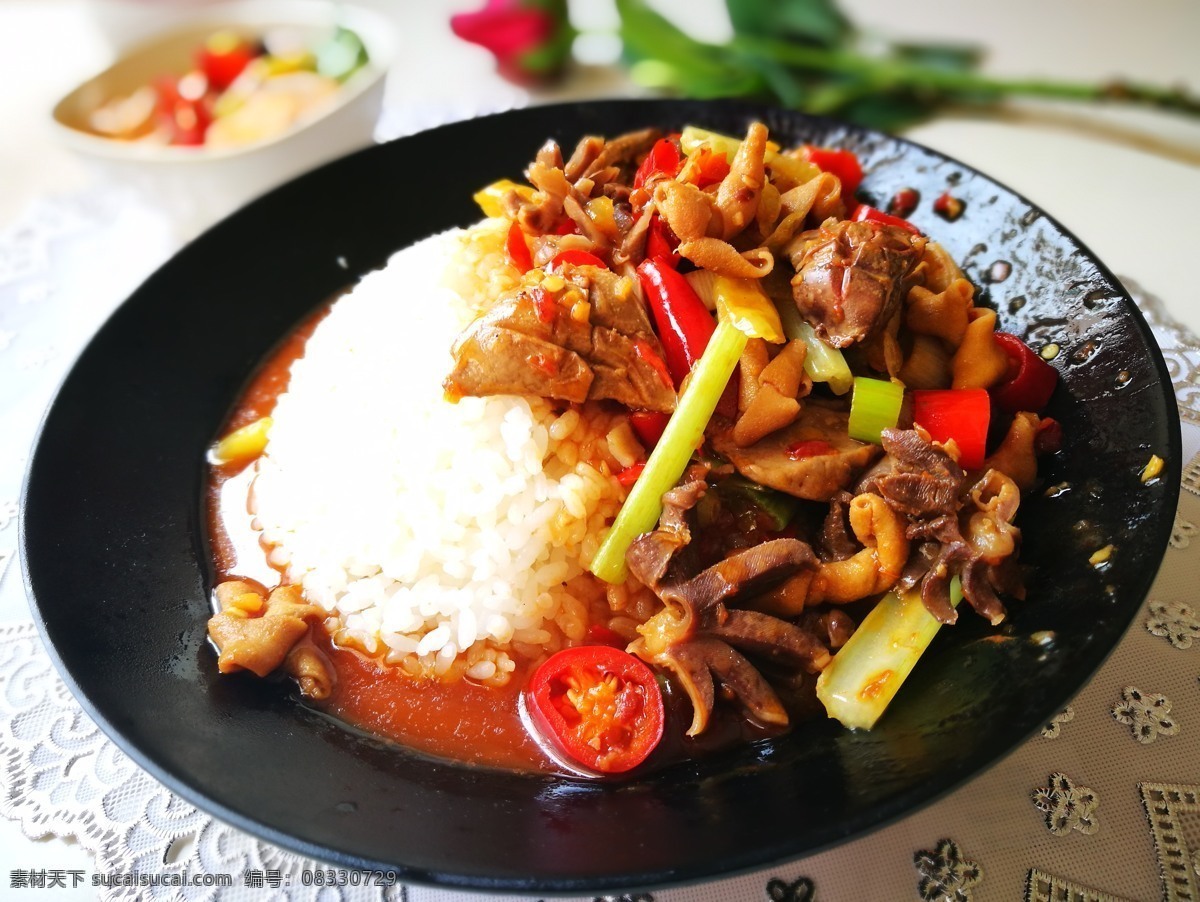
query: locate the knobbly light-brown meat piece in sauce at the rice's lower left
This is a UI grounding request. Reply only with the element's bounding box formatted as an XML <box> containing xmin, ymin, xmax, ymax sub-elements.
<box><xmin>209</xmin><ymin>579</ymin><xmax>325</xmax><ymax>677</ymax></box>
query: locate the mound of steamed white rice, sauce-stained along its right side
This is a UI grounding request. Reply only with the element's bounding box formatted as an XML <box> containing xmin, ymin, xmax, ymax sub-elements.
<box><xmin>251</xmin><ymin>222</ymin><xmax>624</xmax><ymax>685</ymax></box>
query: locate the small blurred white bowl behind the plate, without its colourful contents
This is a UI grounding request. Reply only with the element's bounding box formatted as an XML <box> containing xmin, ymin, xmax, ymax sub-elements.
<box><xmin>52</xmin><ymin>0</ymin><xmax>396</xmax><ymax>237</ymax></box>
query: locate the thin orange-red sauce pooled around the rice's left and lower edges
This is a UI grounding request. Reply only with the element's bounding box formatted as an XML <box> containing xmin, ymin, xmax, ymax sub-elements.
<box><xmin>208</xmin><ymin>307</ymin><xmax>560</xmax><ymax>772</ymax></box>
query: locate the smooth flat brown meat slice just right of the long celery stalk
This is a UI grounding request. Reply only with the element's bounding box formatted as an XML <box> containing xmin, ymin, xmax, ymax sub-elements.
<box><xmin>710</xmin><ymin>404</ymin><xmax>880</xmax><ymax>501</ymax></box>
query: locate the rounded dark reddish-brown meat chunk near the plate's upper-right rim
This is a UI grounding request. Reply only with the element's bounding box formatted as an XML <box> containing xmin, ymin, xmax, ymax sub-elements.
<box><xmin>785</xmin><ymin>220</ymin><xmax>925</xmax><ymax>348</ymax></box>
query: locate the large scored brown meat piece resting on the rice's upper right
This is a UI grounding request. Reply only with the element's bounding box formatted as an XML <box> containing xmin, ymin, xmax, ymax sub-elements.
<box><xmin>444</xmin><ymin>266</ymin><xmax>676</xmax><ymax>413</ymax></box>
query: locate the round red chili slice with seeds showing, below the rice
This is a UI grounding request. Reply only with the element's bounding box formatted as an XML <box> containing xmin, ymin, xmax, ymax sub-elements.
<box><xmin>526</xmin><ymin>645</ymin><xmax>664</xmax><ymax>774</ymax></box>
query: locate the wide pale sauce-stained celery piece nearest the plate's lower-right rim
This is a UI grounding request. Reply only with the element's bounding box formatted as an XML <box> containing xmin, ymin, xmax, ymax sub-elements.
<box><xmin>817</xmin><ymin>577</ymin><xmax>962</xmax><ymax>729</ymax></box>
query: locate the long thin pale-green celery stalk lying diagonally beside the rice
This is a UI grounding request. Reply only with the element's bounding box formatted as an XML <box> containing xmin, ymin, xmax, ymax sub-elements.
<box><xmin>590</xmin><ymin>319</ymin><xmax>748</xmax><ymax>583</ymax></box>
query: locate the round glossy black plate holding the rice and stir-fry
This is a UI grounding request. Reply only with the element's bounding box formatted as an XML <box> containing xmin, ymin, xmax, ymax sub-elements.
<box><xmin>22</xmin><ymin>101</ymin><xmax>1180</xmax><ymax>892</ymax></box>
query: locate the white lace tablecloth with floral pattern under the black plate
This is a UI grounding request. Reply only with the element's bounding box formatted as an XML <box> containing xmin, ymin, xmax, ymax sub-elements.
<box><xmin>0</xmin><ymin>188</ymin><xmax>1200</xmax><ymax>902</ymax></box>
